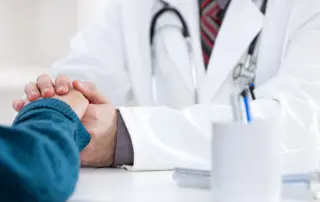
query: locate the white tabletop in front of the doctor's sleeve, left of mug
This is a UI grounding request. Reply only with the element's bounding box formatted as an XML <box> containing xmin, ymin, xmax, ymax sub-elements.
<box><xmin>70</xmin><ymin>169</ymin><xmax>305</xmax><ymax>202</ymax></box>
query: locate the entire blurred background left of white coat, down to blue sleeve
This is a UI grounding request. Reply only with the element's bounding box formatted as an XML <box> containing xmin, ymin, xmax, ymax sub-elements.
<box><xmin>0</xmin><ymin>0</ymin><xmax>109</xmax><ymax>123</ymax></box>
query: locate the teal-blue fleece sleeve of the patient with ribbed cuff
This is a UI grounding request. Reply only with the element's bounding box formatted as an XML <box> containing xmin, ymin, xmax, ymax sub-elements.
<box><xmin>0</xmin><ymin>99</ymin><xmax>90</xmax><ymax>202</ymax></box>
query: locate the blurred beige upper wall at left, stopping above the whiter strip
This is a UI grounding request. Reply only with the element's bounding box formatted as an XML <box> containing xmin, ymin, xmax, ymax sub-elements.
<box><xmin>0</xmin><ymin>0</ymin><xmax>108</xmax><ymax>67</ymax></box>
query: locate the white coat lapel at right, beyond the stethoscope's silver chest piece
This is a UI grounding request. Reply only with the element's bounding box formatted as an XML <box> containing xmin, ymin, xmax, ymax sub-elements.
<box><xmin>255</xmin><ymin>0</ymin><xmax>294</xmax><ymax>87</ymax></box>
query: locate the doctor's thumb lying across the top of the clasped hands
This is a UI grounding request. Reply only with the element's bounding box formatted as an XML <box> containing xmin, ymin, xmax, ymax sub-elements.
<box><xmin>72</xmin><ymin>80</ymin><xmax>109</xmax><ymax>104</ymax></box>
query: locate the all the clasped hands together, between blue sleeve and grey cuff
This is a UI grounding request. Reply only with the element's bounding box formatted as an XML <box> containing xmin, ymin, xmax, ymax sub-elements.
<box><xmin>13</xmin><ymin>75</ymin><xmax>117</xmax><ymax>167</ymax></box>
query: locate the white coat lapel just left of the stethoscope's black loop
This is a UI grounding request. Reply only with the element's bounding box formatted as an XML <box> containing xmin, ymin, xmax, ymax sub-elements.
<box><xmin>122</xmin><ymin>0</ymin><xmax>155</xmax><ymax>105</ymax></box>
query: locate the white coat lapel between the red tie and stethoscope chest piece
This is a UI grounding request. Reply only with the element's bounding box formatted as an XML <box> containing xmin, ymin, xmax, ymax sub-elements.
<box><xmin>200</xmin><ymin>0</ymin><xmax>263</xmax><ymax>103</ymax></box>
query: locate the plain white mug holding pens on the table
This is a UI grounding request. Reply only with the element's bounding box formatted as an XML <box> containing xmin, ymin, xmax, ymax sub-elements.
<box><xmin>212</xmin><ymin>120</ymin><xmax>281</xmax><ymax>202</ymax></box>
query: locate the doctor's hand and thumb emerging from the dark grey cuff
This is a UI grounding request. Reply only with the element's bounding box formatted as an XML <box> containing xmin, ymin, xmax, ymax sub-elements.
<box><xmin>73</xmin><ymin>81</ymin><xmax>117</xmax><ymax>167</ymax></box>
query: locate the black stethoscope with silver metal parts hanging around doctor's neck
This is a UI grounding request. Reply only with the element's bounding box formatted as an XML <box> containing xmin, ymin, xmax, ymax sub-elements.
<box><xmin>149</xmin><ymin>0</ymin><xmax>267</xmax><ymax>104</ymax></box>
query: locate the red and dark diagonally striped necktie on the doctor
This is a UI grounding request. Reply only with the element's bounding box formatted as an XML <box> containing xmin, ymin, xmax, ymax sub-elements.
<box><xmin>200</xmin><ymin>0</ymin><xmax>221</xmax><ymax>69</ymax></box>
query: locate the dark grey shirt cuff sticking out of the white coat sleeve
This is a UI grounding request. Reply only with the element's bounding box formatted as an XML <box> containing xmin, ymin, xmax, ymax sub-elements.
<box><xmin>113</xmin><ymin>111</ymin><xmax>134</xmax><ymax>166</ymax></box>
